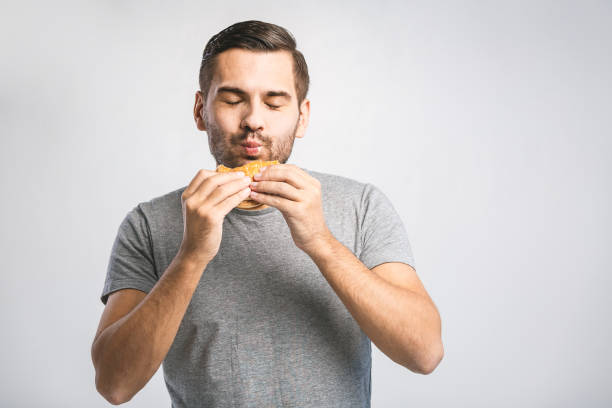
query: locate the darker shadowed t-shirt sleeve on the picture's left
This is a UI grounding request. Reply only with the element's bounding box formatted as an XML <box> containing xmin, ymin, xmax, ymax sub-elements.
<box><xmin>100</xmin><ymin>204</ymin><xmax>158</xmax><ymax>305</ymax></box>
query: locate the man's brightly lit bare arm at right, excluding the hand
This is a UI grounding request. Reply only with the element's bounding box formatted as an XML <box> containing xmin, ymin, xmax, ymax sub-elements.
<box><xmin>309</xmin><ymin>235</ymin><xmax>444</xmax><ymax>374</ymax></box>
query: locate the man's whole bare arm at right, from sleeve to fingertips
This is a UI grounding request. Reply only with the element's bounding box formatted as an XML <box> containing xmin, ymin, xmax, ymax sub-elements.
<box><xmin>251</xmin><ymin>164</ymin><xmax>444</xmax><ymax>374</ymax></box>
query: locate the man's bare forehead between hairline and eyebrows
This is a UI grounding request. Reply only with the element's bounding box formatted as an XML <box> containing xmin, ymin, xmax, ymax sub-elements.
<box><xmin>211</xmin><ymin>48</ymin><xmax>295</xmax><ymax>95</ymax></box>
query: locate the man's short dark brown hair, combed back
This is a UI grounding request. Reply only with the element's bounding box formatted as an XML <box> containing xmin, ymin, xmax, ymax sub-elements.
<box><xmin>199</xmin><ymin>20</ymin><xmax>310</xmax><ymax>106</ymax></box>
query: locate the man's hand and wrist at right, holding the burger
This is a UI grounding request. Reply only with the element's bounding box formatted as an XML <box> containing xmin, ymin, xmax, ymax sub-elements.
<box><xmin>249</xmin><ymin>164</ymin><xmax>331</xmax><ymax>254</ymax></box>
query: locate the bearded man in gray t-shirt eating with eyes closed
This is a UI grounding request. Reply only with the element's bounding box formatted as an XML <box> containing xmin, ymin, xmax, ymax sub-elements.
<box><xmin>92</xmin><ymin>21</ymin><xmax>443</xmax><ymax>408</ymax></box>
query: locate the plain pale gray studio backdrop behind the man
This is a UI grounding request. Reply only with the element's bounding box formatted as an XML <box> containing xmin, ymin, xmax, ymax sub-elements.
<box><xmin>0</xmin><ymin>1</ymin><xmax>612</xmax><ymax>408</ymax></box>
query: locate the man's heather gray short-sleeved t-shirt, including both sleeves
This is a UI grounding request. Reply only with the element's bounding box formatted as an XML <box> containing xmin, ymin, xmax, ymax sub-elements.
<box><xmin>101</xmin><ymin>169</ymin><xmax>415</xmax><ymax>408</ymax></box>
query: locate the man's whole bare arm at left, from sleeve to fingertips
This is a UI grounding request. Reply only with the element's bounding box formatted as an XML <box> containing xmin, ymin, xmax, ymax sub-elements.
<box><xmin>91</xmin><ymin>170</ymin><xmax>251</xmax><ymax>404</ymax></box>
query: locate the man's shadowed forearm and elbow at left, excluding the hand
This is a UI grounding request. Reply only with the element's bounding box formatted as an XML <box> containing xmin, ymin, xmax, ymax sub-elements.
<box><xmin>91</xmin><ymin>253</ymin><xmax>206</xmax><ymax>404</ymax></box>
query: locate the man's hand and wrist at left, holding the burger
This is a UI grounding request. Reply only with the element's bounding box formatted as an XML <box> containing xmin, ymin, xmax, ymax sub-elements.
<box><xmin>179</xmin><ymin>169</ymin><xmax>251</xmax><ymax>264</ymax></box>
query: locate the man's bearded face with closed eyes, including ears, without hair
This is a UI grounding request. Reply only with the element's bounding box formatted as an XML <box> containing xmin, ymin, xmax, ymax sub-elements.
<box><xmin>194</xmin><ymin>49</ymin><xmax>310</xmax><ymax>167</ymax></box>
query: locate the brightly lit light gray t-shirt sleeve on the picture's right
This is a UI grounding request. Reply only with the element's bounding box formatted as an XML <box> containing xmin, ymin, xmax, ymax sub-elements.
<box><xmin>359</xmin><ymin>183</ymin><xmax>416</xmax><ymax>269</ymax></box>
